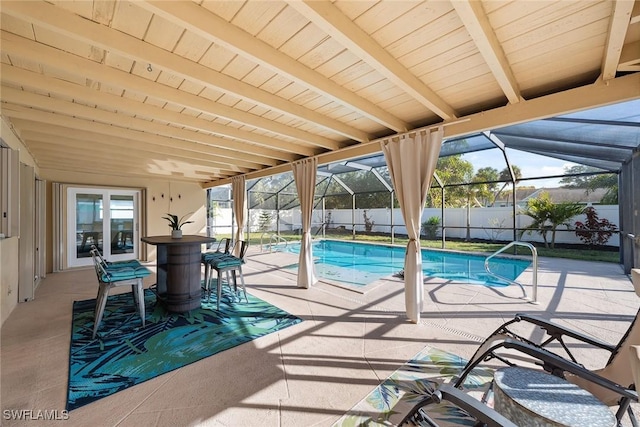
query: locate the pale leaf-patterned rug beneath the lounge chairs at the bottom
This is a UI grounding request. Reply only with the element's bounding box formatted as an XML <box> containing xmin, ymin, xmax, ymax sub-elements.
<box><xmin>333</xmin><ymin>347</ymin><xmax>493</xmax><ymax>427</ymax></box>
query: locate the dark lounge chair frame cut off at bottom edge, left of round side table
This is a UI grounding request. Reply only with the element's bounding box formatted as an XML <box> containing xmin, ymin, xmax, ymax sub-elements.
<box><xmin>398</xmin><ymin>384</ymin><xmax>517</xmax><ymax>427</ymax></box>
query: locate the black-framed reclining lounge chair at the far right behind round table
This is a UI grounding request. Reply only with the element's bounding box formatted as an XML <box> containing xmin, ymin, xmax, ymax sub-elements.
<box><xmin>454</xmin><ymin>270</ymin><xmax>640</xmax><ymax>427</ymax></box>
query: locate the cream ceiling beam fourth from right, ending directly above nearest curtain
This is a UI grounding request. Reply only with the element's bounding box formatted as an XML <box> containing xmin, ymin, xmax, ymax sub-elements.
<box><xmin>138</xmin><ymin>1</ymin><xmax>409</xmax><ymax>132</ymax></box>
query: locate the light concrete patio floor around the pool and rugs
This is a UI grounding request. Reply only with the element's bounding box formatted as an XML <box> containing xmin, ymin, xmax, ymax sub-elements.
<box><xmin>0</xmin><ymin>248</ymin><xmax>640</xmax><ymax>427</ymax></box>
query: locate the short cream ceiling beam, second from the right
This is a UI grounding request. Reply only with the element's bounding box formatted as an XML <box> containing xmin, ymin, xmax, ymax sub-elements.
<box><xmin>451</xmin><ymin>0</ymin><xmax>522</xmax><ymax>104</ymax></box>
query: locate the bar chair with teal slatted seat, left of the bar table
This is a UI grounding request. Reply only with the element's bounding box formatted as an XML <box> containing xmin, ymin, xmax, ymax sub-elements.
<box><xmin>91</xmin><ymin>249</ymin><xmax>151</xmax><ymax>339</ymax></box>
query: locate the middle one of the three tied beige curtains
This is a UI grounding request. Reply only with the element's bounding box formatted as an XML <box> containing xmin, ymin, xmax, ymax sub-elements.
<box><xmin>291</xmin><ymin>157</ymin><xmax>318</xmax><ymax>288</ymax></box>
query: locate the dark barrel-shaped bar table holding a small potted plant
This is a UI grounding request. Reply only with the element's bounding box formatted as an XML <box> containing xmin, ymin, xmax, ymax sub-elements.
<box><xmin>140</xmin><ymin>235</ymin><xmax>216</xmax><ymax>313</ymax></box>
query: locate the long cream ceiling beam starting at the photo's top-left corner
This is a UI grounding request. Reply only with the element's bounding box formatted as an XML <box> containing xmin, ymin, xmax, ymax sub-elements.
<box><xmin>2</xmin><ymin>0</ymin><xmax>370</xmax><ymax>144</ymax></box>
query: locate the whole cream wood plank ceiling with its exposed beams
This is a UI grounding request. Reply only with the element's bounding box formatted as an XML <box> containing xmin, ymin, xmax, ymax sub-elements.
<box><xmin>0</xmin><ymin>0</ymin><xmax>640</xmax><ymax>186</ymax></box>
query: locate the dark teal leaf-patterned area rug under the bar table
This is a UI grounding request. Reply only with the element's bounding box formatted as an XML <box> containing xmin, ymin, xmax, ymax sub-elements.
<box><xmin>66</xmin><ymin>288</ymin><xmax>302</xmax><ymax>411</ymax></box>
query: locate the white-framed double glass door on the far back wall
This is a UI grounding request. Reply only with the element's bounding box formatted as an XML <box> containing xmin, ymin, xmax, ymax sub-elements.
<box><xmin>67</xmin><ymin>188</ymin><xmax>140</xmax><ymax>267</ymax></box>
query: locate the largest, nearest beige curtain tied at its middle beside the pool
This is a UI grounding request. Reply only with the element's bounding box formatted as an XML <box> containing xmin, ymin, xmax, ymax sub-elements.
<box><xmin>380</xmin><ymin>127</ymin><xmax>443</xmax><ymax>323</ymax></box>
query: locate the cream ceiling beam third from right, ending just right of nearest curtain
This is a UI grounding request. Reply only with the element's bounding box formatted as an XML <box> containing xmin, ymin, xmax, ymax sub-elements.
<box><xmin>287</xmin><ymin>0</ymin><xmax>456</xmax><ymax>120</ymax></box>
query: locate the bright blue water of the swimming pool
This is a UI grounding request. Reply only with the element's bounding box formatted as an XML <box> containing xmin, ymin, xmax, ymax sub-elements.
<box><xmin>286</xmin><ymin>240</ymin><xmax>531</xmax><ymax>286</ymax></box>
